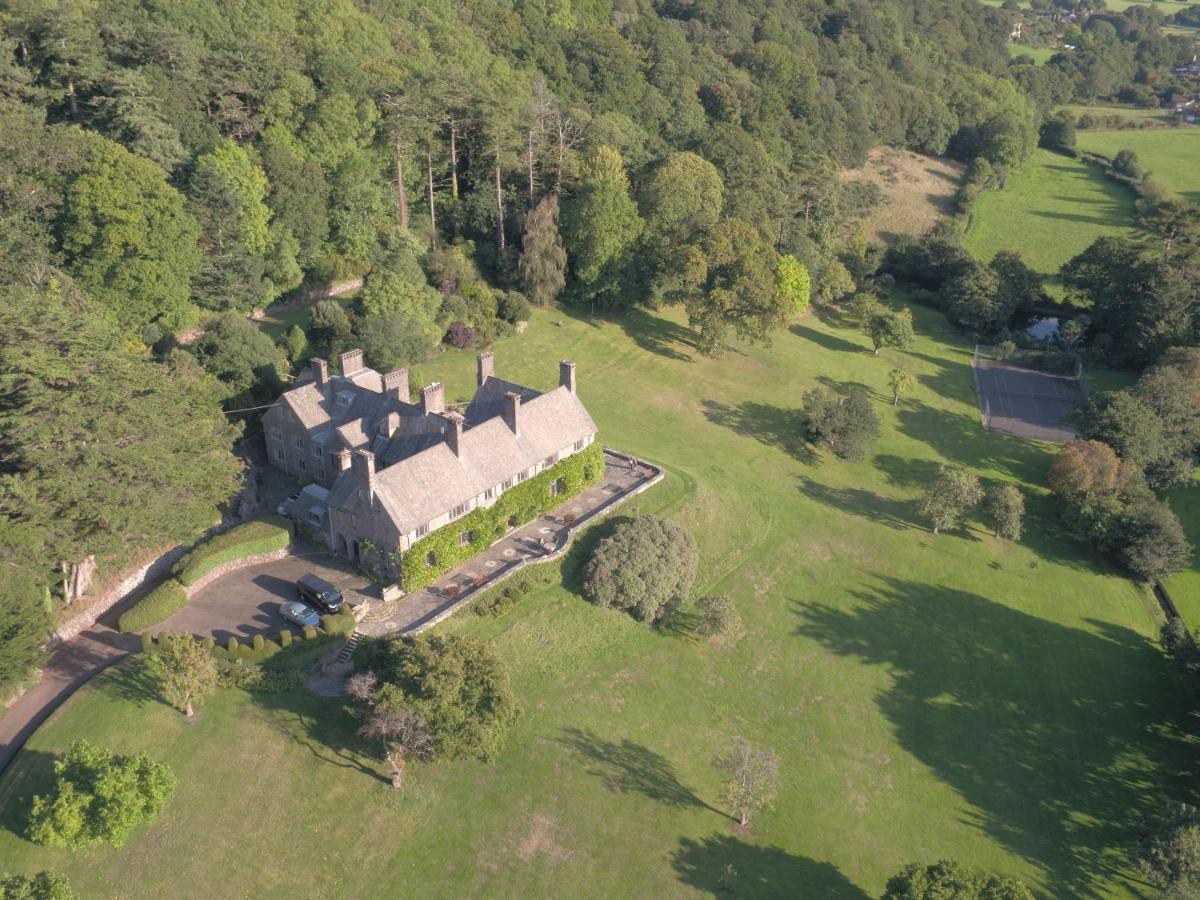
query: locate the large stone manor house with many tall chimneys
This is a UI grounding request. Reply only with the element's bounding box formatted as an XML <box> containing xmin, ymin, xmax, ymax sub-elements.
<box><xmin>263</xmin><ymin>350</ymin><xmax>596</xmax><ymax>571</ymax></box>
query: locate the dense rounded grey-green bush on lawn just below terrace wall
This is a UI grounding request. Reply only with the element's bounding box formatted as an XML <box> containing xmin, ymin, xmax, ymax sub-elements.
<box><xmin>583</xmin><ymin>516</ymin><xmax>696</xmax><ymax>624</ymax></box>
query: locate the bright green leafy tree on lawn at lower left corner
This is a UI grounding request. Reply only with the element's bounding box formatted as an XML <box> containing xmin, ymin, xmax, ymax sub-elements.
<box><xmin>29</xmin><ymin>739</ymin><xmax>175</xmax><ymax>848</ymax></box>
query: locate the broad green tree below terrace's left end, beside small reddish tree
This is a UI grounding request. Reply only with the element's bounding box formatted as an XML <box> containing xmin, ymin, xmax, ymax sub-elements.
<box><xmin>354</xmin><ymin>636</ymin><xmax>520</xmax><ymax>760</ymax></box>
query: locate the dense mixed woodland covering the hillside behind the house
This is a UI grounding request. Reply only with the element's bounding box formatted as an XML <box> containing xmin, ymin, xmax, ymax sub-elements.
<box><xmin>0</xmin><ymin>0</ymin><xmax>1190</xmax><ymax>691</ymax></box>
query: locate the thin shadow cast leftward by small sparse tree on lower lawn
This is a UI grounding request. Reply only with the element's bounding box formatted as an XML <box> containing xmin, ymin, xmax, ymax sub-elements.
<box><xmin>557</xmin><ymin>727</ymin><xmax>731</xmax><ymax>818</ymax></box>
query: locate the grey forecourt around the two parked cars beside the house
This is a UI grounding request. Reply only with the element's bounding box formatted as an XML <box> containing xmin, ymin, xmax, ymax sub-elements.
<box><xmin>149</xmin><ymin>551</ymin><xmax>372</xmax><ymax>642</ymax></box>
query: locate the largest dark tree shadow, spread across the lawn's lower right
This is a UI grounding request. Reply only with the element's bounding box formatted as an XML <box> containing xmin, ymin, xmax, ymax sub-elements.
<box><xmin>793</xmin><ymin>577</ymin><xmax>1196</xmax><ymax>898</ymax></box>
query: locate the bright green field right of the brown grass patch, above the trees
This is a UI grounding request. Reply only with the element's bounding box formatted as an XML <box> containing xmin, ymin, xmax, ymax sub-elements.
<box><xmin>965</xmin><ymin>148</ymin><xmax>1134</xmax><ymax>275</ymax></box>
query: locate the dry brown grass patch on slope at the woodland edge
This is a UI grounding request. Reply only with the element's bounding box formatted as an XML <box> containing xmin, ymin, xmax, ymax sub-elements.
<box><xmin>842</xmin><ymin>146</ymin><xmax>962</xmax><ymax>242</ymax></box>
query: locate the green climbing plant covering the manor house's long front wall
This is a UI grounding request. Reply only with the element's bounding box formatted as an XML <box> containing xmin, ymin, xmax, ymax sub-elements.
<box><xmin>400</xmin><ymin>443</ymin><xmax>604</xmax><ymax>592</ymax></box>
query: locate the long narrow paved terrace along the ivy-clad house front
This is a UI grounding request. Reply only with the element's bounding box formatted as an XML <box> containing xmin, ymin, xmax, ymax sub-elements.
<box><xmin>359</xmin><ymin>449</ymin><xmax>662</xmax><ymax>637</ymax></box>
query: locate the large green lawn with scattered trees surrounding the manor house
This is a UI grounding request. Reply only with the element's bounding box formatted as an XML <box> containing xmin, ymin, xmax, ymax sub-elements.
<box><xmin>0</xmin><ymin>308</ymin><xmax>1196</xmax><ymax>900</ymax></box>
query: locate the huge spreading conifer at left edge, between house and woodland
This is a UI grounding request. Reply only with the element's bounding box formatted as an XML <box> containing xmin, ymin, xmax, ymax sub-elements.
<box><xmin>0</xmin><ymin>288</ymin><xmax>240</xmax><ymax>595</ymax></box>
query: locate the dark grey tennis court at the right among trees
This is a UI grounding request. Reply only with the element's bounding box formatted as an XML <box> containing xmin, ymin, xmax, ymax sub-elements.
<box><xmin>974</xmin><ymin>356</ymin><xmax>1086</xmax><ymax>444</ymax></box>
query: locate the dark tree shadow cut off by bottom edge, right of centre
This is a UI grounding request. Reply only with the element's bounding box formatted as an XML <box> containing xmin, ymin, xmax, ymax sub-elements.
<box><xmin>671</xmin><ymin>834</ymin><xmax>868</xmax><ymax>900</ymax></box>
